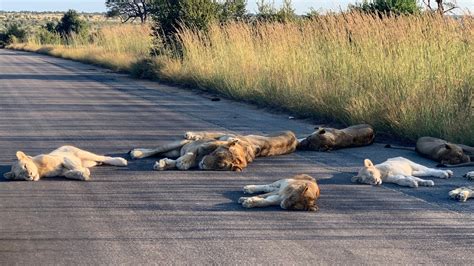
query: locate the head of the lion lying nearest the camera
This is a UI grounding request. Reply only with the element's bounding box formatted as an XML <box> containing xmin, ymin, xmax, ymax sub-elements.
<box><xmin>280</xmin><ymin>180</ymin><xmax>319</xmax><ymax>211</ymax></box>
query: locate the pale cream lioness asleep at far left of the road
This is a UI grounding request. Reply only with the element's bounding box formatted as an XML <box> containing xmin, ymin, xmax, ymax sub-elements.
<box><xmin>3</xmin><ymin>146</ymin><xmax>127</xmax><ymax>181</ymax></box>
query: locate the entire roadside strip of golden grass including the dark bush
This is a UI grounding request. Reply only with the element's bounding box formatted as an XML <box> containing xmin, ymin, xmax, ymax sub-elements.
<box><xmin>4</xmin><ymin>1</ymin><xmax>474</xmax><ymax>145</ymax></box>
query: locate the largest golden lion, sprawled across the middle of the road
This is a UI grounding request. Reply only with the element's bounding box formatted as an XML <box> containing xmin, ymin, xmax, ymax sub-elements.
<box><xmin>130</xmin><ymin>131</ymin><xmax>298</xmax><ymax>171</ymax></box>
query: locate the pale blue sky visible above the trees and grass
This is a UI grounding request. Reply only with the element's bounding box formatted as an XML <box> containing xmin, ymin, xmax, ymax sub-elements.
<box><xmin>0</xmin><ymin>0</ymin><xmax>474</xmax><ymax>14</ymax></box>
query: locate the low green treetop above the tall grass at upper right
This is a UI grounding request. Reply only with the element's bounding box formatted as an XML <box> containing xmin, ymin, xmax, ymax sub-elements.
<box><xmin>349</xmin><ymin>0</ymin><xmax>421</xmax><ymax>15</ymax></box>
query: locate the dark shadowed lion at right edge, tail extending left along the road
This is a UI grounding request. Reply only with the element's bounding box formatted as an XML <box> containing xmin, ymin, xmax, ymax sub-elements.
<box><xmin>385</xmin><ymin>137</ymin><xmax>474</xmax><ymax>167</ymax></box>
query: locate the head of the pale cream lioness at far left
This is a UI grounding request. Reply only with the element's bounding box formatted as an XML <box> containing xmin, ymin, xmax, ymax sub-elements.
<box><xmin>3</xmin><ymin>151</ymin><xmax>39</xmax><ymax>181</ymax></box>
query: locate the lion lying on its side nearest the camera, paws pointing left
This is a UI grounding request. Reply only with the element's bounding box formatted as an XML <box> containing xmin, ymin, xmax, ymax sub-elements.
<box><xmin>239</xmin><ymin>175</ymin><xmax>320</xmax><ymax>211</ymax></box>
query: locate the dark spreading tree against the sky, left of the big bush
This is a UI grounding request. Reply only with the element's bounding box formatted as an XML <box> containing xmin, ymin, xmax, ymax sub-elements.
<box><xmin>105</xmin><ymin>0</ymin><xmax>152</xmax><ymax>23</ymax></box>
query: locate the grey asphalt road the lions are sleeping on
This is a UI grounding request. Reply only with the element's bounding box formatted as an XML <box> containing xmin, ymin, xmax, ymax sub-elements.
<box><xmin>0</xmin><ymin>50</ymin><xmax>474</xmax><ymax>265</ymax></box>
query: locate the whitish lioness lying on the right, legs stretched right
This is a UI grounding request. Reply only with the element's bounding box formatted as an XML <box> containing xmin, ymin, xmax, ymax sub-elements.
<box><xmin>351</xmin><ymin>157</ymin><xmax>453</xmax><ymax>187</ymax></box>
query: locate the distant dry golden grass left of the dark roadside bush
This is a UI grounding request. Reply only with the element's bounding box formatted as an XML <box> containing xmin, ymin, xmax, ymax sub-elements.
<box><xmin>9</xmin><ymin>24</ymin><xmax>152</xmax><ymax>71</ymax></box>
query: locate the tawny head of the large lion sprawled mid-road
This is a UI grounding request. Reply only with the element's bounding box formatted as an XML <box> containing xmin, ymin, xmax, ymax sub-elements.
<box><xmin>199</xmin><ymin>139</ymin><xmax>247</xmax><ymax>172</ymax></box>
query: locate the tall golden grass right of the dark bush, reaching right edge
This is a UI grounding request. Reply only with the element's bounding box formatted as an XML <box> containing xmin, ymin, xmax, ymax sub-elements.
<box><xmin>160</xmin><ymin>14</ymin><xmax>474</xmax><ymax>144</ymax></box>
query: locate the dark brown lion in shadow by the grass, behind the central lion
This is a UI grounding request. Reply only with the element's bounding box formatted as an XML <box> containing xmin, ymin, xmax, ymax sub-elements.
<box><xmin>298</xmin><ymin>124</ymin><xmax>375</xmax><ymax>151</ymax></box>
